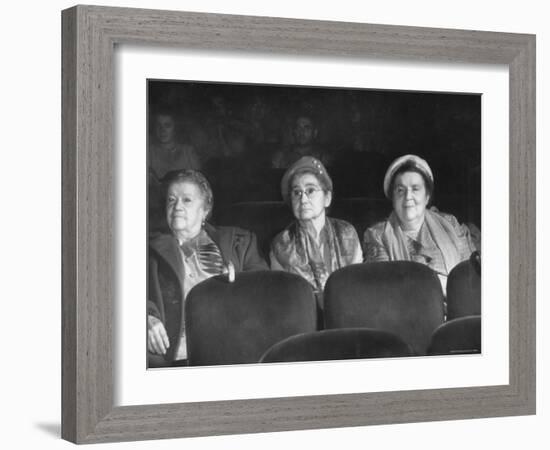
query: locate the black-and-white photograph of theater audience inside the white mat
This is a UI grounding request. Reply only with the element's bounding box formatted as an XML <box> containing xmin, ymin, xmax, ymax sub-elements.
<box><xmin>144</xmin><ymin>79</ymin><xmax>482</xmax><ymax>369</ymax></box>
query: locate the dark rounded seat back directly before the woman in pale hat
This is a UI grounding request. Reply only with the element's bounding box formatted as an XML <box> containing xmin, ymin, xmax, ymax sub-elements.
<box><xmin>324</xmin><ymin>261</ymin><xmax>444</xmax><ymax>355</ymax></box>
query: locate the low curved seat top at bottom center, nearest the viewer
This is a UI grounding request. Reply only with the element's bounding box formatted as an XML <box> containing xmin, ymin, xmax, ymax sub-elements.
<box><xmin>260</xmin><ymin>328</ymin><xmax>412</xmax><ymax>363</ymax></box>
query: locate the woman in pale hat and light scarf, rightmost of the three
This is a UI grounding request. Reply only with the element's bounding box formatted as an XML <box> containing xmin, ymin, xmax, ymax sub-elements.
<box><xmin>364</xmin><ymin>155</ymin><xmax>477</xmax><ymax>292</ymax></box>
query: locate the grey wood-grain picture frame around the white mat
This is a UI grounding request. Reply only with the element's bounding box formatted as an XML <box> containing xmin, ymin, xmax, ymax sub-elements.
<box><xmin>62</xmin><ymin>6</ymin><xmax>535</xmax><ymax>443</ymax></box>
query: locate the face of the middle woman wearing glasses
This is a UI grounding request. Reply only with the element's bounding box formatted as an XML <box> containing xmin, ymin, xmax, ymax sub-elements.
<box><xmin>290</xmin><ymin>173</ymin><xmax>332</xmax><ymax>220</ymax></box>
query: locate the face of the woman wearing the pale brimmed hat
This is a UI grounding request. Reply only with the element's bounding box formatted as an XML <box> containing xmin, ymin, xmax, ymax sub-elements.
<box><xmin>392</xmin><ymin>172</ymin><xmax>430</xmax><ymax>227</ymax></box>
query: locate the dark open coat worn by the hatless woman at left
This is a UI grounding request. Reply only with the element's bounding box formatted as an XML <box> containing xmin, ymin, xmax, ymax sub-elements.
<box><xmin>147</xmin><ymin>224</ymin><xmax>268</xmax><ymax>361</ymax></box>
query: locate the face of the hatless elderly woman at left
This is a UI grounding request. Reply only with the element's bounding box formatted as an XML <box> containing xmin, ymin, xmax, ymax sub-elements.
<box><xmin>166</xmin><ymin>181</ymin><xmax>208</xmax><ymax>237</ymax></box>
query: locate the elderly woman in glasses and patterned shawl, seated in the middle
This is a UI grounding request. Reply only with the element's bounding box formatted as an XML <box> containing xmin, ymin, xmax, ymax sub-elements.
<box><xmin>270</xmin><ymin>156</ymin><xmax>363</xmax><ymax>307</ymax></box>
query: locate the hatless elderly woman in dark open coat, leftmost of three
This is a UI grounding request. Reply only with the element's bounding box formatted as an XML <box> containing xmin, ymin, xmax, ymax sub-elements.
<box><xmin>147</xmin><ymin>169</ymin><xmax>268</xmax><ymax>367</ymax></box>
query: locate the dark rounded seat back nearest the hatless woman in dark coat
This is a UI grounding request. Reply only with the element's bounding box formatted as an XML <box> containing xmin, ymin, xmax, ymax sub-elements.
<box><xmin>185</xmin><ymin>271</ymin><xmax>317</xmax><ymax>365</ymax></box>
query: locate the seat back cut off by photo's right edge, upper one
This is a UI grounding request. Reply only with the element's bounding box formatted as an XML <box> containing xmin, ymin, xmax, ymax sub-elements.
<box><xmin>447</xmin><ymin>255</ymin><xmax>481</xmax><ymax>320</ymax></box>
